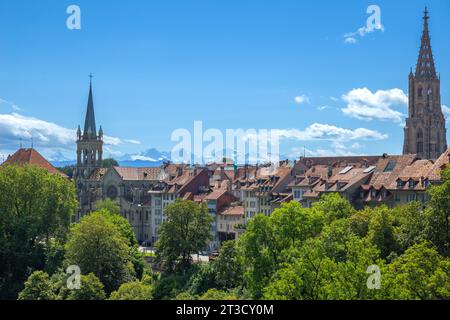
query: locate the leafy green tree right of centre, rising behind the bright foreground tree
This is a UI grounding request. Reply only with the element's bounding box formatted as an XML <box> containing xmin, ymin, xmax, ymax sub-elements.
<box><xmin>238</xmin><ymin>198</ymin><xmax>330</xmax><ymax>298</ymax></box>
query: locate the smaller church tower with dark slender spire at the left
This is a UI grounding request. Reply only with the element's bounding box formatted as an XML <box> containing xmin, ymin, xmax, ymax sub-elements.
<box><xmin>74</xmin><ymin>75</ymin><xmax>103</xmax><ymax>184</ymax></box>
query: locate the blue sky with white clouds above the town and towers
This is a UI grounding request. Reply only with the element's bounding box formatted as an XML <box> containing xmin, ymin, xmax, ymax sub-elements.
<box><xmin>0</xmin><ymin>0</ymin><xmax>450</xmax><ymax>162</ymax></box>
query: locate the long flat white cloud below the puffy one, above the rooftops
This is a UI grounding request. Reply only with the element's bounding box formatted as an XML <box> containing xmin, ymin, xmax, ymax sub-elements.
<box><xmin>273</xmin><ymin>123</ymin><xmax>388</xmax><ymax>141</ymax></box>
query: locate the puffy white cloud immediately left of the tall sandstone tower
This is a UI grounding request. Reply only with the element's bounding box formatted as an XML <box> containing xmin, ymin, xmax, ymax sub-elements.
<box><xmin>341</xmin><ymin>88</ymin><xmax>408</xmax><ymax>123</ymax></box>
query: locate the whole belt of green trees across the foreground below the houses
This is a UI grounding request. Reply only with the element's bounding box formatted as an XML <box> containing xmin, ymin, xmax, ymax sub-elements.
<box><xmin>0</xmin><ymin>166</ymin><xmax>450</xmax><ymax>300</ymax></box>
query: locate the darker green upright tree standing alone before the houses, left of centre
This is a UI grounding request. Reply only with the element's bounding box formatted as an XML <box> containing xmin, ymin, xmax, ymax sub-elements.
<box><xmin>156</xmin><ymin>200</ymin><xmax>211</xmax><ymax>271</ymax></box>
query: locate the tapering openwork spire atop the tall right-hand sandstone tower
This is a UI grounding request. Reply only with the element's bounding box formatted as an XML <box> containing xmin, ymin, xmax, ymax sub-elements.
<box><xmin>416</xmin><ymin>7</ymin><xmax>437</xmax><ymax>78</ymax></box>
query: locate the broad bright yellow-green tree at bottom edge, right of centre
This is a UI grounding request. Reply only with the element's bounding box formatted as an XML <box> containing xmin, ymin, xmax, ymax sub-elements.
<box><xmin>264</xmin><ymin>234</ymin><xmax>383</xmax><ymax>300</ymax></box>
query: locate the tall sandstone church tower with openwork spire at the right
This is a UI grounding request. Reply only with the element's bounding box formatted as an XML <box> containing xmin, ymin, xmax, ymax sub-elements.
<box><xmin>403</xmin><ymin>8</ymin><xmax>447</xmax><ymax>159</ymax></box>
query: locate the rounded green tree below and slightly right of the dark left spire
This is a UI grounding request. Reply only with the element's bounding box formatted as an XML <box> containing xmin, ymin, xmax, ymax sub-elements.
<box><xmin>66</xmin><ymin>212</ymin><xmax>135</xmax><ymax>293</ymax></box>
